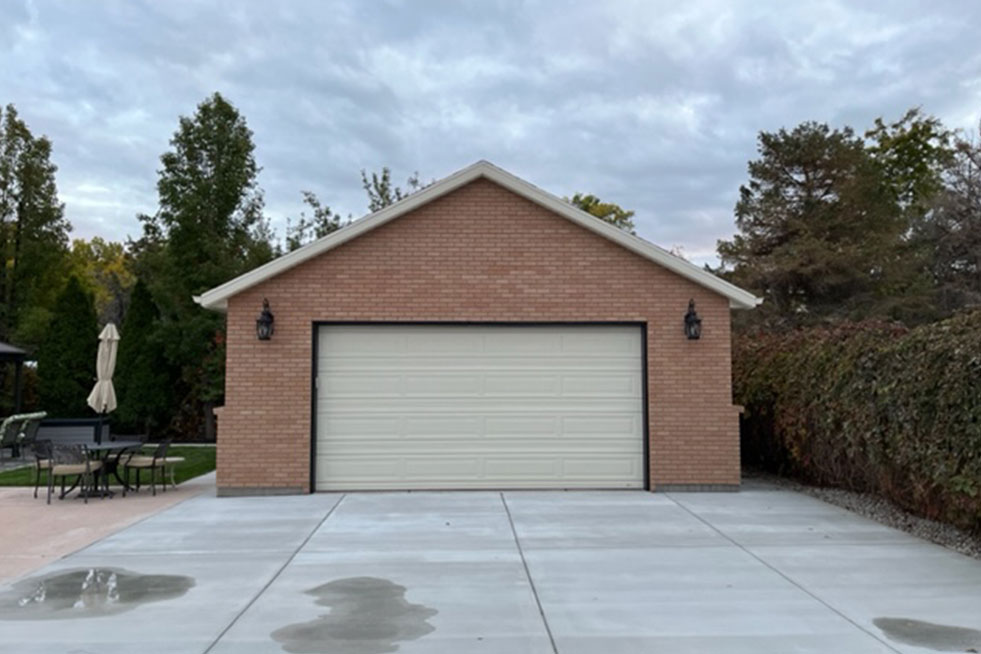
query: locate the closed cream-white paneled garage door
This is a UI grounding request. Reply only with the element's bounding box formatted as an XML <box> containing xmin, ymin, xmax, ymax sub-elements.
<box><xmin>316</xmin><ymin>325</ymin><xmax>644</xmax><ymax>490</ymax></box>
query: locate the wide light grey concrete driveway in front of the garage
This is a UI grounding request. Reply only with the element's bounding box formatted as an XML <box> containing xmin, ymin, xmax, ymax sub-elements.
<box><xmin>0</xmin><ymin>490</ymin><xmax>981</xmax><ymax>654</ymax></box>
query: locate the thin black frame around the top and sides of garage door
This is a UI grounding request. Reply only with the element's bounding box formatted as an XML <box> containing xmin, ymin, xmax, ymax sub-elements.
<box><xmin>302</xmin><ymin>320</ymin><xmax>651</xmax><ymax>493</ymax></box>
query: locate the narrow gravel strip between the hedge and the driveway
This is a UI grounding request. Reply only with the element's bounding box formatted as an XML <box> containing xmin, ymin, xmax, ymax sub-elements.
<box><xmin>743</xmin><ymin>470</ymin><xmax>981</xmax><ymax>559</ymax></box>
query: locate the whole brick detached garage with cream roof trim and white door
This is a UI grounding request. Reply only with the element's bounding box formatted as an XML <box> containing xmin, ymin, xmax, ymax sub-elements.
<box><xmin>196</xmin><ymin>162</ymin><xmax>758</xmax><ymax>495</ymax></box>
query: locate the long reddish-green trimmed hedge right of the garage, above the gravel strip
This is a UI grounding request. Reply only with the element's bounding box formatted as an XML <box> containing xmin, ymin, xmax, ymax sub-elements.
<box><xmin>733</xmin><ymin>311</ymin><xmax>981</xmax><ymax>532</ymax></box>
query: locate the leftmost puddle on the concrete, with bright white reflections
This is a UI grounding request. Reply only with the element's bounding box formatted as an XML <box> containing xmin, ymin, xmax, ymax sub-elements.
<box><xmin>0</xmin><ymin>568</ymin><xmax>194</xmax><ymax>620</ymax></box>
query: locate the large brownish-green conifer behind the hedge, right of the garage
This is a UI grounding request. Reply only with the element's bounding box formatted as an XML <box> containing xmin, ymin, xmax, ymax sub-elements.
<box><xmin>718</xmin><ymin>122</ymin><xmax>908</xmax><ymax>322</ymax></box>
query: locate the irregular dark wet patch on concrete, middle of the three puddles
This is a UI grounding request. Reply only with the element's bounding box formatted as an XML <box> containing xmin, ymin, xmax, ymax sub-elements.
<box><xmin>272</xmin><ymin>577</ymin><xmax>438</xmax><ymax>654</ymax></box>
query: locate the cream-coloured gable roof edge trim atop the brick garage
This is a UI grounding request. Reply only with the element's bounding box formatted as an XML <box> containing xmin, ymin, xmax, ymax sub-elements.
<box><xmin>194</xmin><ymin>161</ymin><xmax>763</xmax><ymax>311</ymax></box>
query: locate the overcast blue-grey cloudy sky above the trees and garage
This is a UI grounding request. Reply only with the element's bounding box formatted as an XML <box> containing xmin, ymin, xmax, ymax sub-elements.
<box><xmin>0</xmin><ymin>0</ymin><xmax>981</xmax><ymax>262</ymax></box>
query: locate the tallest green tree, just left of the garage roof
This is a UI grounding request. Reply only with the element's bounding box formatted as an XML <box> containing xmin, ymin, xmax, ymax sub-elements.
<box><xmin>131</xmin><ymin>93</ymin><xmax>273</xmax><ymax>440</ymax></box>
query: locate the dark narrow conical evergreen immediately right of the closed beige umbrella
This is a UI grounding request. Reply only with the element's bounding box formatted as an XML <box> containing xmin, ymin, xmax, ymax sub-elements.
<box><xmin>114</xmin><ymin>280</ymin><xmax>173</xmax><ymax>434</ymax></box>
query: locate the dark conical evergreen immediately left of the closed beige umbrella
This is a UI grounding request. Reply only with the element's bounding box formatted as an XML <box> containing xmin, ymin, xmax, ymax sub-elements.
<box><xmin>37</xmin><ymin>275</ymin><xmax>99</xmax><ymax>417</ymax></box>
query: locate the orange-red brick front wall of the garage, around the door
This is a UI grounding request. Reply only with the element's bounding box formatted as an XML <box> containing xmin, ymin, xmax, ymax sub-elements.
<box><xmin>218</xmin><ymin>180</ymin><xmax>739</xmax><ymax>493</ymax></box>
